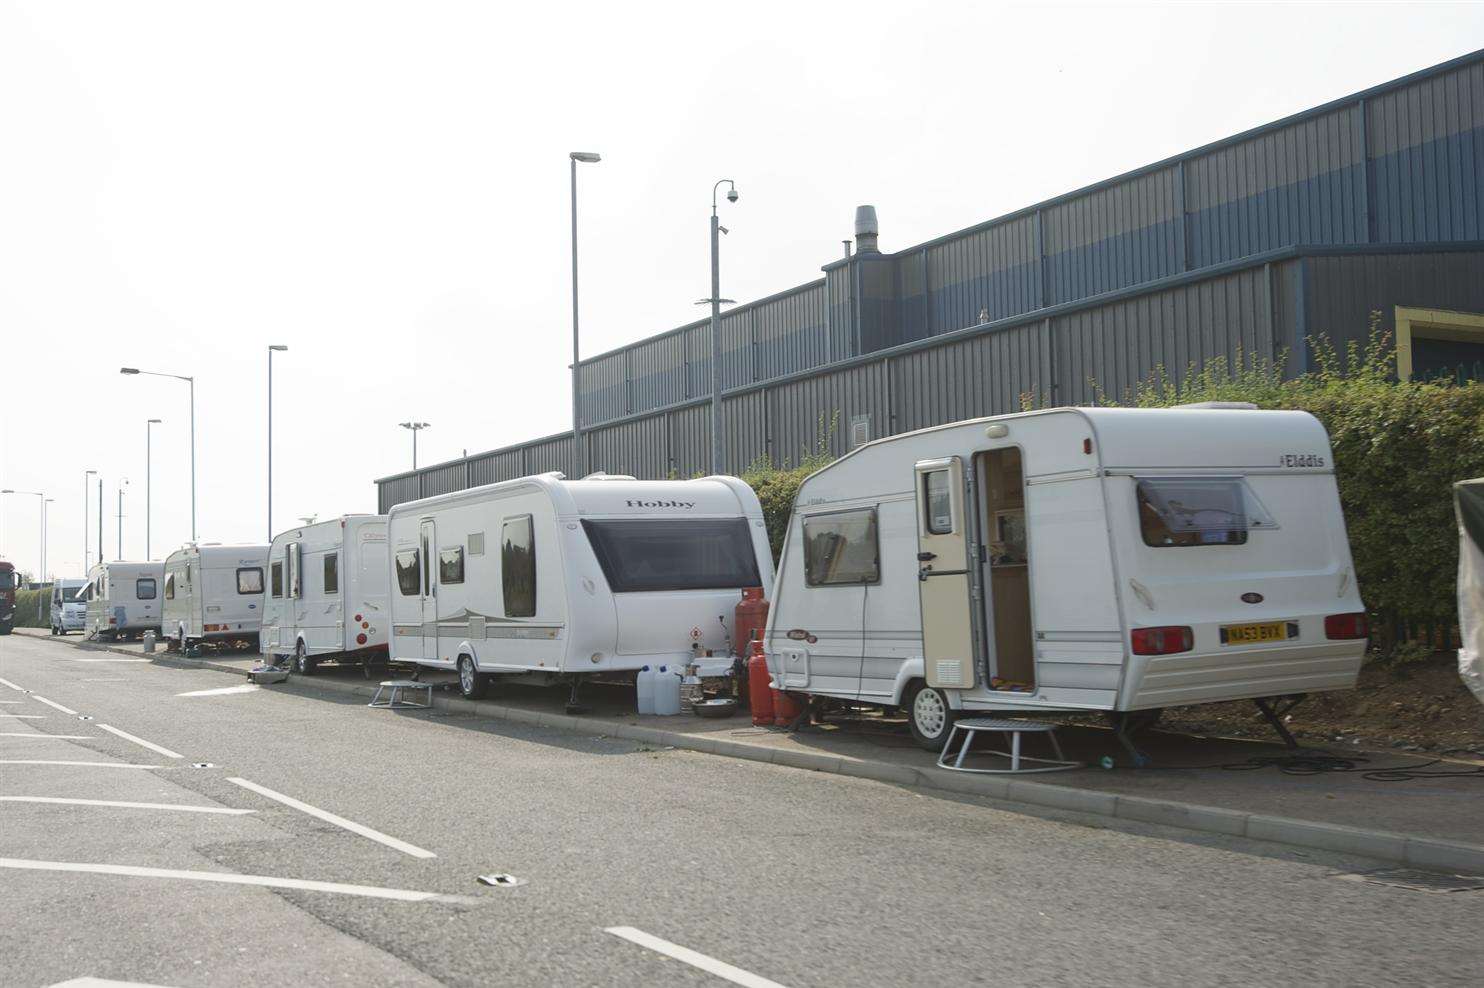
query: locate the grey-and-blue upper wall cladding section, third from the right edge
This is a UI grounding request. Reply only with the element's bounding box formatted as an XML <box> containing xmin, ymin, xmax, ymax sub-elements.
<box><xmin>1042</xmin><ymin>168</ymin><xmax>1184</xmax><ymax>304</ymax></box>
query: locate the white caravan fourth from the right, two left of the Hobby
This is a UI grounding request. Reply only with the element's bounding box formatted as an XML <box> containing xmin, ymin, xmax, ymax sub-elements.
<box><xmin>163</xmin><ymin>543</ymin><xmax>269</xmax><ymax>651</ymax></box>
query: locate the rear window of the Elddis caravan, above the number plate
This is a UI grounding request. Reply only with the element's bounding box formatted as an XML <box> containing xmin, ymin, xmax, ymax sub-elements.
<box><xmin>1135</xmin><ymin>476</ymin><xmax>1278</xmax><ymax>549</ymax></box>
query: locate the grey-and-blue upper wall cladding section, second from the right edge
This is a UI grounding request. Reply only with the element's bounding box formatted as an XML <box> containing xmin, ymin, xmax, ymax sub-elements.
<box><xmin>1184</xmin><ymin>104</ymin><xmax>1365</xmax><ymax>269</ymax></box>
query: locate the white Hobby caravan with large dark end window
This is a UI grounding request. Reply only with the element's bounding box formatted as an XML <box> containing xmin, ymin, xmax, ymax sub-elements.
<box><xmin>387</xmin><ymin>473</ymin><xmax>773</xmax><ymax>702</ymax></box>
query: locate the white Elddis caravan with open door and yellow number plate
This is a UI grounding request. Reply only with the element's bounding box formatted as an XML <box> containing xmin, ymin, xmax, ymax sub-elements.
<box><xmin>766</xmin><ymin>404</ymin><xmax>1367</xmax><ymax>757</ymax></box>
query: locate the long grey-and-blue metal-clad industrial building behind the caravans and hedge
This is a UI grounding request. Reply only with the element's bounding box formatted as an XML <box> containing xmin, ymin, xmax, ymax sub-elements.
<box><xmin>377</xmin><ymin>50</ymin><xmax>1484</xmax><ymax>512</ymax></box>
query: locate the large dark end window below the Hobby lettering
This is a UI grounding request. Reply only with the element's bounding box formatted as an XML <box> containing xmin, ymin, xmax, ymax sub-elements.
<box><xmin>582</xmin><ymin>518</ymin><xmax>761</xmax><ymax>593</ymax></box>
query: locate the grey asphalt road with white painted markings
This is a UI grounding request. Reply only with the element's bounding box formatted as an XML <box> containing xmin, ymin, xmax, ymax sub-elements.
<box><xmin>0</xmin><ymin>636</ymin><xmax>1484</xmax><ymax>988</ymax></box>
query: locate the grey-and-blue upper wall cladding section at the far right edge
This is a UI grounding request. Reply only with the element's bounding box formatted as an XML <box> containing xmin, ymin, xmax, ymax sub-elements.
<box><xmin>1367</xmin><ymin>62</ymin><xmax>1484</xmax><ymax>243</ymax></box>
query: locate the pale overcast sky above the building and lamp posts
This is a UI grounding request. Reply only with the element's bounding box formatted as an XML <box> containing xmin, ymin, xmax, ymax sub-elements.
<box><xmin>0</xmin><ymin>0</ymin><xmax>1484</xmax><ymax>576</ymax></box>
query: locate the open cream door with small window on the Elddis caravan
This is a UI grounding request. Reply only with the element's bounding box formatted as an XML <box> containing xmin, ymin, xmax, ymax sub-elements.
<box><xmin>916</xmin><ymin>457</ymin><xmax>975</xmax><ymax>690</ymax></box>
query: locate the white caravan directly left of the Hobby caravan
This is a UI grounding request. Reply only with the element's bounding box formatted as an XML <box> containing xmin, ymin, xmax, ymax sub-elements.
<box><xmin>263</xmin><ymin>515</ymin><xmax>392</xmax><ymax>675</ymax></box>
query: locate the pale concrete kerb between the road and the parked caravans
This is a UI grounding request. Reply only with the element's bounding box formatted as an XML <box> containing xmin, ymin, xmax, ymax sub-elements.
<box><xmin>23</xmin><ymin>638</ymin><xmax>1484</xmax><ymax>874</ymax></box>
